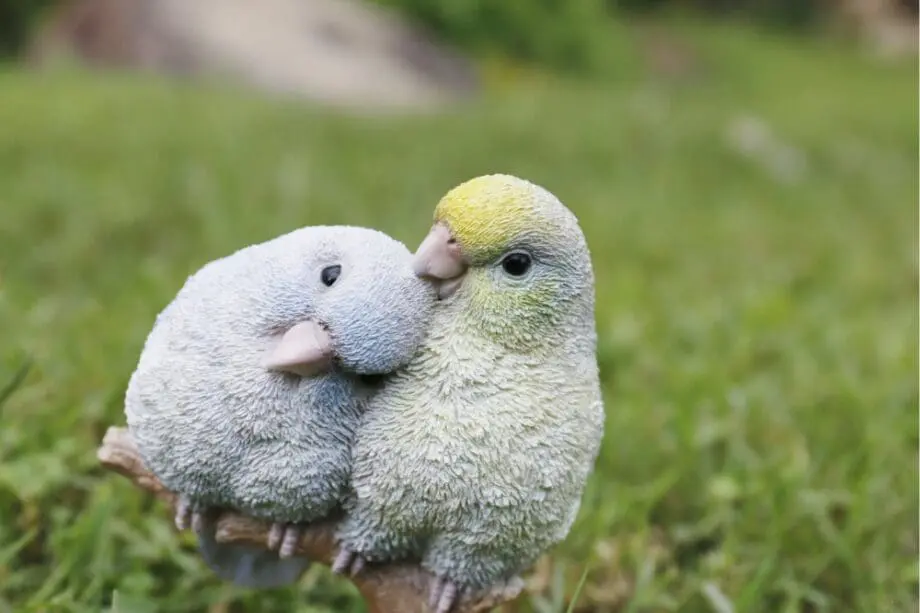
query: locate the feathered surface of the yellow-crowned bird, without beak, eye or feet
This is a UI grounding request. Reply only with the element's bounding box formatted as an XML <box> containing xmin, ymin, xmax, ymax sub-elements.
<box><xmin>341</xmin><ymin>175</ymin><xmax>604</xmax><ymax>589</ymax></box>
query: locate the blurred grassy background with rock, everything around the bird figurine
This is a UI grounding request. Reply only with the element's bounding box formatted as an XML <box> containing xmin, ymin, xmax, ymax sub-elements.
<box><xmin>0</xmin><ymin>0</ymin><xmax>918</xmax><ymax>613</ymax></box>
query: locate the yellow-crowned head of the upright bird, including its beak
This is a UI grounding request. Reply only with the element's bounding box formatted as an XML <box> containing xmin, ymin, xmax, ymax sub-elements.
<box><xmin>414</xmin><ymin>174</ymin><xmax>594</xmax><ymax>349</ymax></box>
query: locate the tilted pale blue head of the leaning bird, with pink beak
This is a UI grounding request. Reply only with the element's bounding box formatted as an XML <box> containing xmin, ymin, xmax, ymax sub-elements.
<box><xmin>263</xmin><ymin>226</ymin><xmax>435</xmax><ymax>376</ymax></box>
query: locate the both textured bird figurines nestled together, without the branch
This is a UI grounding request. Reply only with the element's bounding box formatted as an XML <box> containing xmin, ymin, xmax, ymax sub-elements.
<box><xmin>126</xmin><ymin>175</ymin><xmax>604</xmax><ymax>613</ymax></box>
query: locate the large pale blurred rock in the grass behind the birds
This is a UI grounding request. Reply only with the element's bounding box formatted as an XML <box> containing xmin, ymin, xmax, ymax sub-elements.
<box><xmin>29</xmin><ymin>0</ymin><xmax>477</xmax><ymax>110</ymax></box>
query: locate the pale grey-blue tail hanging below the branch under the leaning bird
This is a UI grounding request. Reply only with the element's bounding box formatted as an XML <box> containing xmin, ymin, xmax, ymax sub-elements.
<box><xmin>198</xmin><ymin>529</ymin><xmax>310</xmax><ymax>589</ymax></box>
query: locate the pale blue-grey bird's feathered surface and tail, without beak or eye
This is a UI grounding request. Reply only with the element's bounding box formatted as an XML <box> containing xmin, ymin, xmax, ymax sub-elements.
<box><xmin>125</xmin><ymin>226</ymin><xmax>434</xmax><ymax>586</ymax></box>
